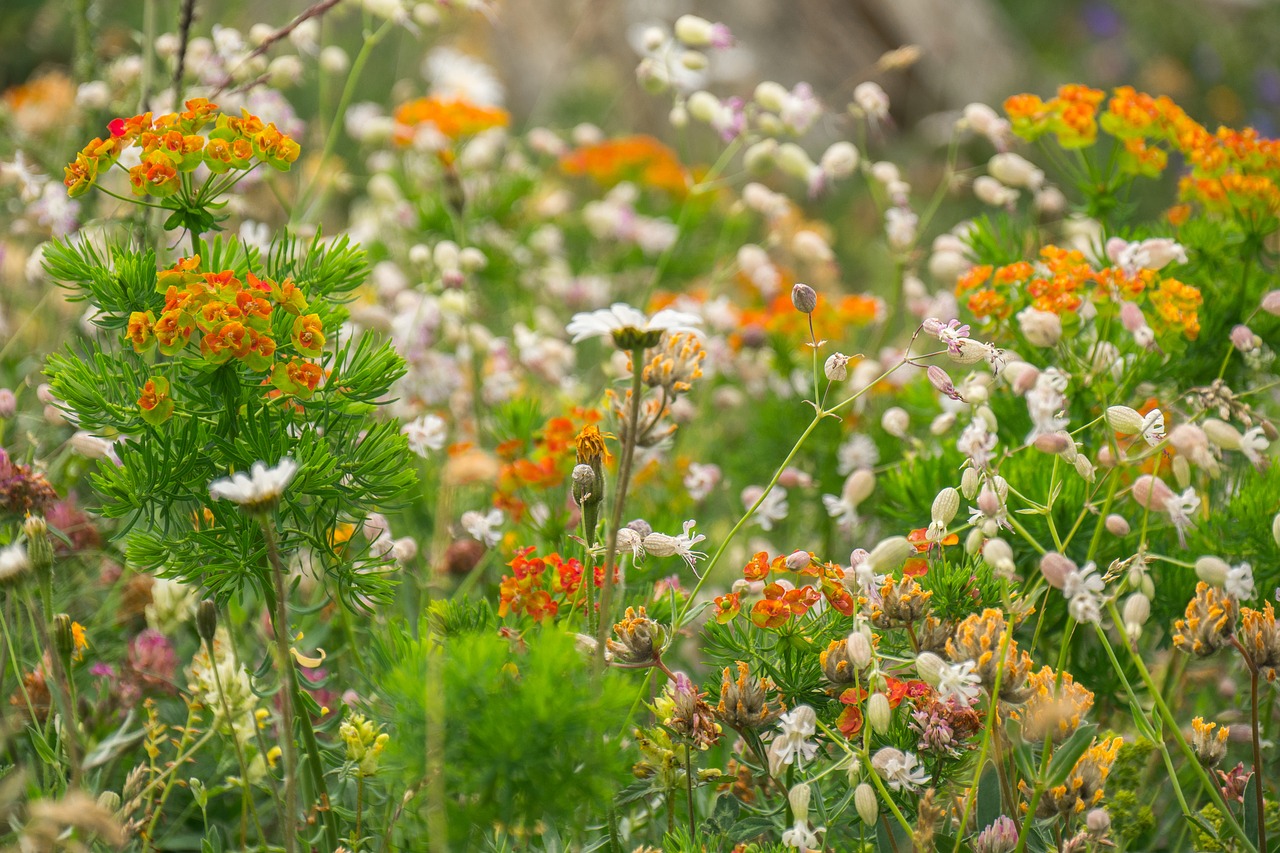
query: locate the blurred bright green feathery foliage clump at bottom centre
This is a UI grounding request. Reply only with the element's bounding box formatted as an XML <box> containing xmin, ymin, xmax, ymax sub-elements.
<box><xmin>370</xmin><ymin>625</ymin><xmax>636</xmax><ymax>849</ymax></box>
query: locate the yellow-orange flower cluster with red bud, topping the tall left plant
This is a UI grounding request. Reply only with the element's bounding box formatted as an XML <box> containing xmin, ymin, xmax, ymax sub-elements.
<box><xmin>63</xmin><ymin>97</ymin><xmax>301</xmax><ymax>199</ymax></box>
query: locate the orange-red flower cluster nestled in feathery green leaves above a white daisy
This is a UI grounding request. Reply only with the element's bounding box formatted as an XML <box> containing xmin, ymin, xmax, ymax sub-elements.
<box><xmin>125</xmin><ymin>255</ymin><xmax>325</xmax><ymax>423</ymax></box>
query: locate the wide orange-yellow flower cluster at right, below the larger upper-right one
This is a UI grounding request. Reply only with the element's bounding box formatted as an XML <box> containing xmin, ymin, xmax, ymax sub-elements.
<box><xmin>956</xmin><ymin>240</ymin><xmax>1202</xmax><ymax>341</ymax></box>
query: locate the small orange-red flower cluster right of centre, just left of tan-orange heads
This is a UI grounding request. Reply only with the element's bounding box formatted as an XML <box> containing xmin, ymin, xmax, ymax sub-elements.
<box><xmin>716</xmin><ymin>551</ymin><xmax>854</xmax><ymax>628</ymax></box>
